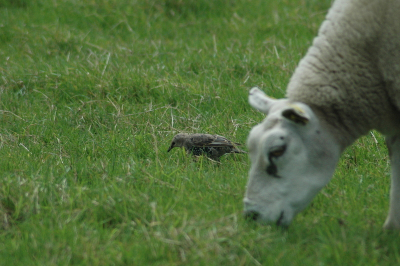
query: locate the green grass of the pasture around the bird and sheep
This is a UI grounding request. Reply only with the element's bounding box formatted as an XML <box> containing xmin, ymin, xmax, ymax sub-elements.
<box><xmin>0</xmin><ymin>0</ymin><xmax>400</xmax><ymax>265</ymax></box>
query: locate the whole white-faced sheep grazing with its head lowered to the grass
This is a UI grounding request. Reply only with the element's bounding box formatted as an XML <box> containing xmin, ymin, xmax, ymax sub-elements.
<box><xmin>243</xmin><ymin>0</ymin><xmax>400</xmax><ymax>229</ymax></box>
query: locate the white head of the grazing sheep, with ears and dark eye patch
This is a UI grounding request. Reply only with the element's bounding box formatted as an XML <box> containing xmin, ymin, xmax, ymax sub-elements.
<box><xmin>244</xmin><ymin>88</ymin><xmax>340</xmax><ymax>226</ymax></box>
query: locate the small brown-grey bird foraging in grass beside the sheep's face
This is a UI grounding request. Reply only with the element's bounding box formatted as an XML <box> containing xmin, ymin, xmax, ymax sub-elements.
<box><xmin>168</xmin><ymin>133</ymin><xmax>247</xmax><ymax>161</ymax></box>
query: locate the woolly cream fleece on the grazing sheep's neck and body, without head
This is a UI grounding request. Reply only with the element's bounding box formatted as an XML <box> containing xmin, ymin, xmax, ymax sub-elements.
<box><xmin>287</xmin><ymin>0</ymin><xmax>400</xmax><ymax>146</ymax></box>
